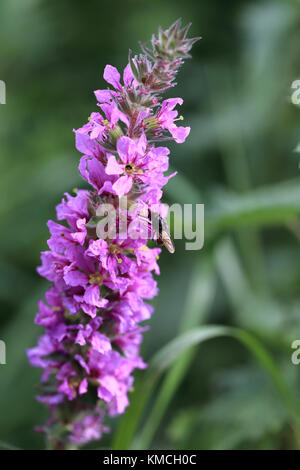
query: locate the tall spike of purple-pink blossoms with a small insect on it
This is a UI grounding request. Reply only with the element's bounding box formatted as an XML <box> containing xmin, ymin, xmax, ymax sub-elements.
<box><xmin>28</xmin><ymin>21</ymin><xmax>199</xmax><ymax>449</ymax></box>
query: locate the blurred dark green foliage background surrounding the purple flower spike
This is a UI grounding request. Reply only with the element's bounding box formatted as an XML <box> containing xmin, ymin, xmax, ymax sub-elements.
<box><xmin>0</xmin><ymin>0</ymin><xmax>300</xmax><ymax>449</ymax></box>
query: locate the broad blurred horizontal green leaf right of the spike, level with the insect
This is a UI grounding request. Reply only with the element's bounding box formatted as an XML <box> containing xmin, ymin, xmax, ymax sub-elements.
<box><xmin>166</xmin><ymin>169</ymin><xmax>300</xmax><ymax>237</ymax></box>
